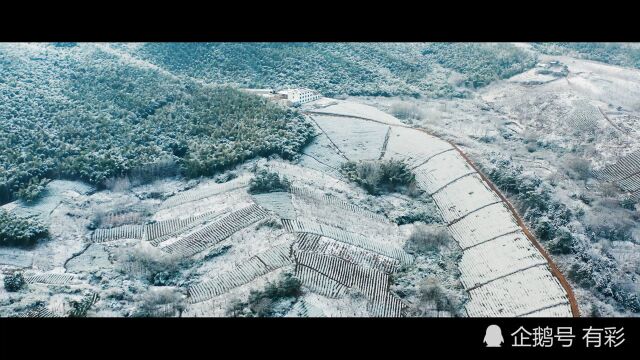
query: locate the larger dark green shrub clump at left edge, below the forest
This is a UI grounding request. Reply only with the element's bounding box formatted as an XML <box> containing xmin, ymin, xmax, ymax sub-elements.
<box><xmin>0</xmin><ymin>209</ymin><xmax>49</xmax><ymax>246</ymax></box>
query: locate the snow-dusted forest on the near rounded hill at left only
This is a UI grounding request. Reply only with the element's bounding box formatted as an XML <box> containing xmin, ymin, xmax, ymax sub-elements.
<box><xmin>0</xmin><ymin>44</ymin><xmax>313</xmax><ymax>203</ymax></box>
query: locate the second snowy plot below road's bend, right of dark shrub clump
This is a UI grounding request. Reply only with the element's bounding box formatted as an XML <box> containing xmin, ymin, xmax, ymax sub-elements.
<box><xmin>414</xmin><ymin>151</ymin><xmax>476</xmax><ymax>194</ymax></box>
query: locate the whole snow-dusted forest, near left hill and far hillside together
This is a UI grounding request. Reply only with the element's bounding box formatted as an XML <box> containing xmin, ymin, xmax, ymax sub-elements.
<box><xmin>0</xmin><ymin>43</ymin><xmax>535</xmax><ymax>204</ymax></box>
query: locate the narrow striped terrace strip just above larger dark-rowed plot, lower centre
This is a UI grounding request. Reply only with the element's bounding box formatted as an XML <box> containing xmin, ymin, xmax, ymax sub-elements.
<box><xmin>297</xmin><ymin>233</ymin><xmax>400</xmax><ymax>274</ymax></box>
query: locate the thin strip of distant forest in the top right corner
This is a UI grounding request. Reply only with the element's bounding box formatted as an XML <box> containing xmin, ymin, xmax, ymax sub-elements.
<box><xmin>534</xmin><ymin>43</ymin><xmax>640</xmax><ymax>69</ymax></box>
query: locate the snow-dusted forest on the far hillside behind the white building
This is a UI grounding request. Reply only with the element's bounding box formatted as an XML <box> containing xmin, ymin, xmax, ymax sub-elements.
<box><xmin>136</xmin><ymin>43</ymin><xmax>535</xmax><ymax>97</ymax></box>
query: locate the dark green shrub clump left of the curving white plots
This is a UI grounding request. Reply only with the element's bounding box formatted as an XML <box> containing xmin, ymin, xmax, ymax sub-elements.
<box><xmin>341</xmin><ymin>159</ymin><xmax>415</xmax><ymax>195</ymax></box>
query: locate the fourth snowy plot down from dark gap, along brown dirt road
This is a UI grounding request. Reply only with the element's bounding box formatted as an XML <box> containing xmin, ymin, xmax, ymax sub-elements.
<box><xmin>449</xmin><ymin>203</ymin><xmax>520</xmax><ymax>250</ymax></box>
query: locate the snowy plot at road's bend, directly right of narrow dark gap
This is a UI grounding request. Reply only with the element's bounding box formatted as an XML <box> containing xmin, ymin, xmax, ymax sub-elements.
<box><xmin>383</xmin><ymin>126</ymin><xmax>454</xmax><ymax>168</ymax></box>
